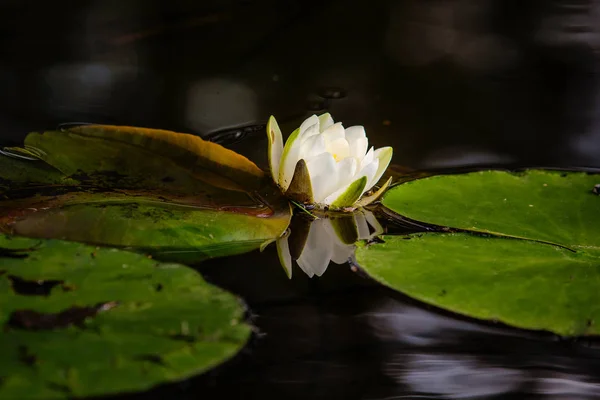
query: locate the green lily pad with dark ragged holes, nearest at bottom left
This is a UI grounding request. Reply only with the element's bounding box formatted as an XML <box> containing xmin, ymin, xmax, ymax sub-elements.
<box><xmin>0</xmin><ymin>236</ymin><xmax>250</xmax><ymax>399</ymax></box>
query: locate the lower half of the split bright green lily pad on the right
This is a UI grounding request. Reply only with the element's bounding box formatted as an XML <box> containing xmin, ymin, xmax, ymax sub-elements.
<box><xmin>356</xmin><ymin>233</ymin><xmax>600</xmax><ymax>336</ymax></box>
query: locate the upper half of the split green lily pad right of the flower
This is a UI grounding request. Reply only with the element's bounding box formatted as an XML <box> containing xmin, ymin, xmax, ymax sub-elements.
<box><xmin>382</xmin><ymin>170</ymin><xmax>600</xmax><ymax>251</ymax></box>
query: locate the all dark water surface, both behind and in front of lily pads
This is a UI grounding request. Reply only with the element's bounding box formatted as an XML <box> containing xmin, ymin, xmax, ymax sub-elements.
<box><xmin>0</xmin><ymin>0</ymin><xmax>600</xmax><ymax>400</ymax></box>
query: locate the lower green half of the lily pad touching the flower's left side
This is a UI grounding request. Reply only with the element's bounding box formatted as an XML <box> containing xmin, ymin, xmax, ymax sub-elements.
<box><xmin>0</xmin><ymin>192</ymin><xmax>291</xmax><ymax>263</ymax></box>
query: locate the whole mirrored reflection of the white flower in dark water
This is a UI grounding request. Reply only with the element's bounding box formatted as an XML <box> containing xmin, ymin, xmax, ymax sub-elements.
<box><xmin>277</xmin><ymin>209</ymin><xmax>383</xmax><ymax>278</ymax></box>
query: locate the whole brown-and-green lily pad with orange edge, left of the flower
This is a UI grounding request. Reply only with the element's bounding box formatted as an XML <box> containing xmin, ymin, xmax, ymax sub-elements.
<box><xmin>0</xmin><ymin>125</ymin><xmax>291</xmax><ymax>263</ymax></box>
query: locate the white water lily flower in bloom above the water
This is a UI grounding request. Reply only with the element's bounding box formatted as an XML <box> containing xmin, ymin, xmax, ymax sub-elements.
<box><xmin>267</xmin><ymin>113</ymin><xmax>393</xmax><ymax>209</ymax></box>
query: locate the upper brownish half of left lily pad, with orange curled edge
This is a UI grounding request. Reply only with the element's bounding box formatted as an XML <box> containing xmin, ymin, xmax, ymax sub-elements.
<box><xmin>6</xmin><ymin>125</ymin><xmax>264</xmax><ymax>191</ymax></box>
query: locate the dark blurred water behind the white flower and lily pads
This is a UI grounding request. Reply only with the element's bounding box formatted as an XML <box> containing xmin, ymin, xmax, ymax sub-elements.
<box><xmin>0</xmin><ymin>0</ymin><xmax>600</xmax><ymax>167</ymax></box>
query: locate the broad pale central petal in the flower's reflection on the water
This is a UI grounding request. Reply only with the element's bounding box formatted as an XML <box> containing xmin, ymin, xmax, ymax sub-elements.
<box><xmin>298</xmin><ymin>219</ymin><xmax>333</xmax><ymax>276</ymax></box>
